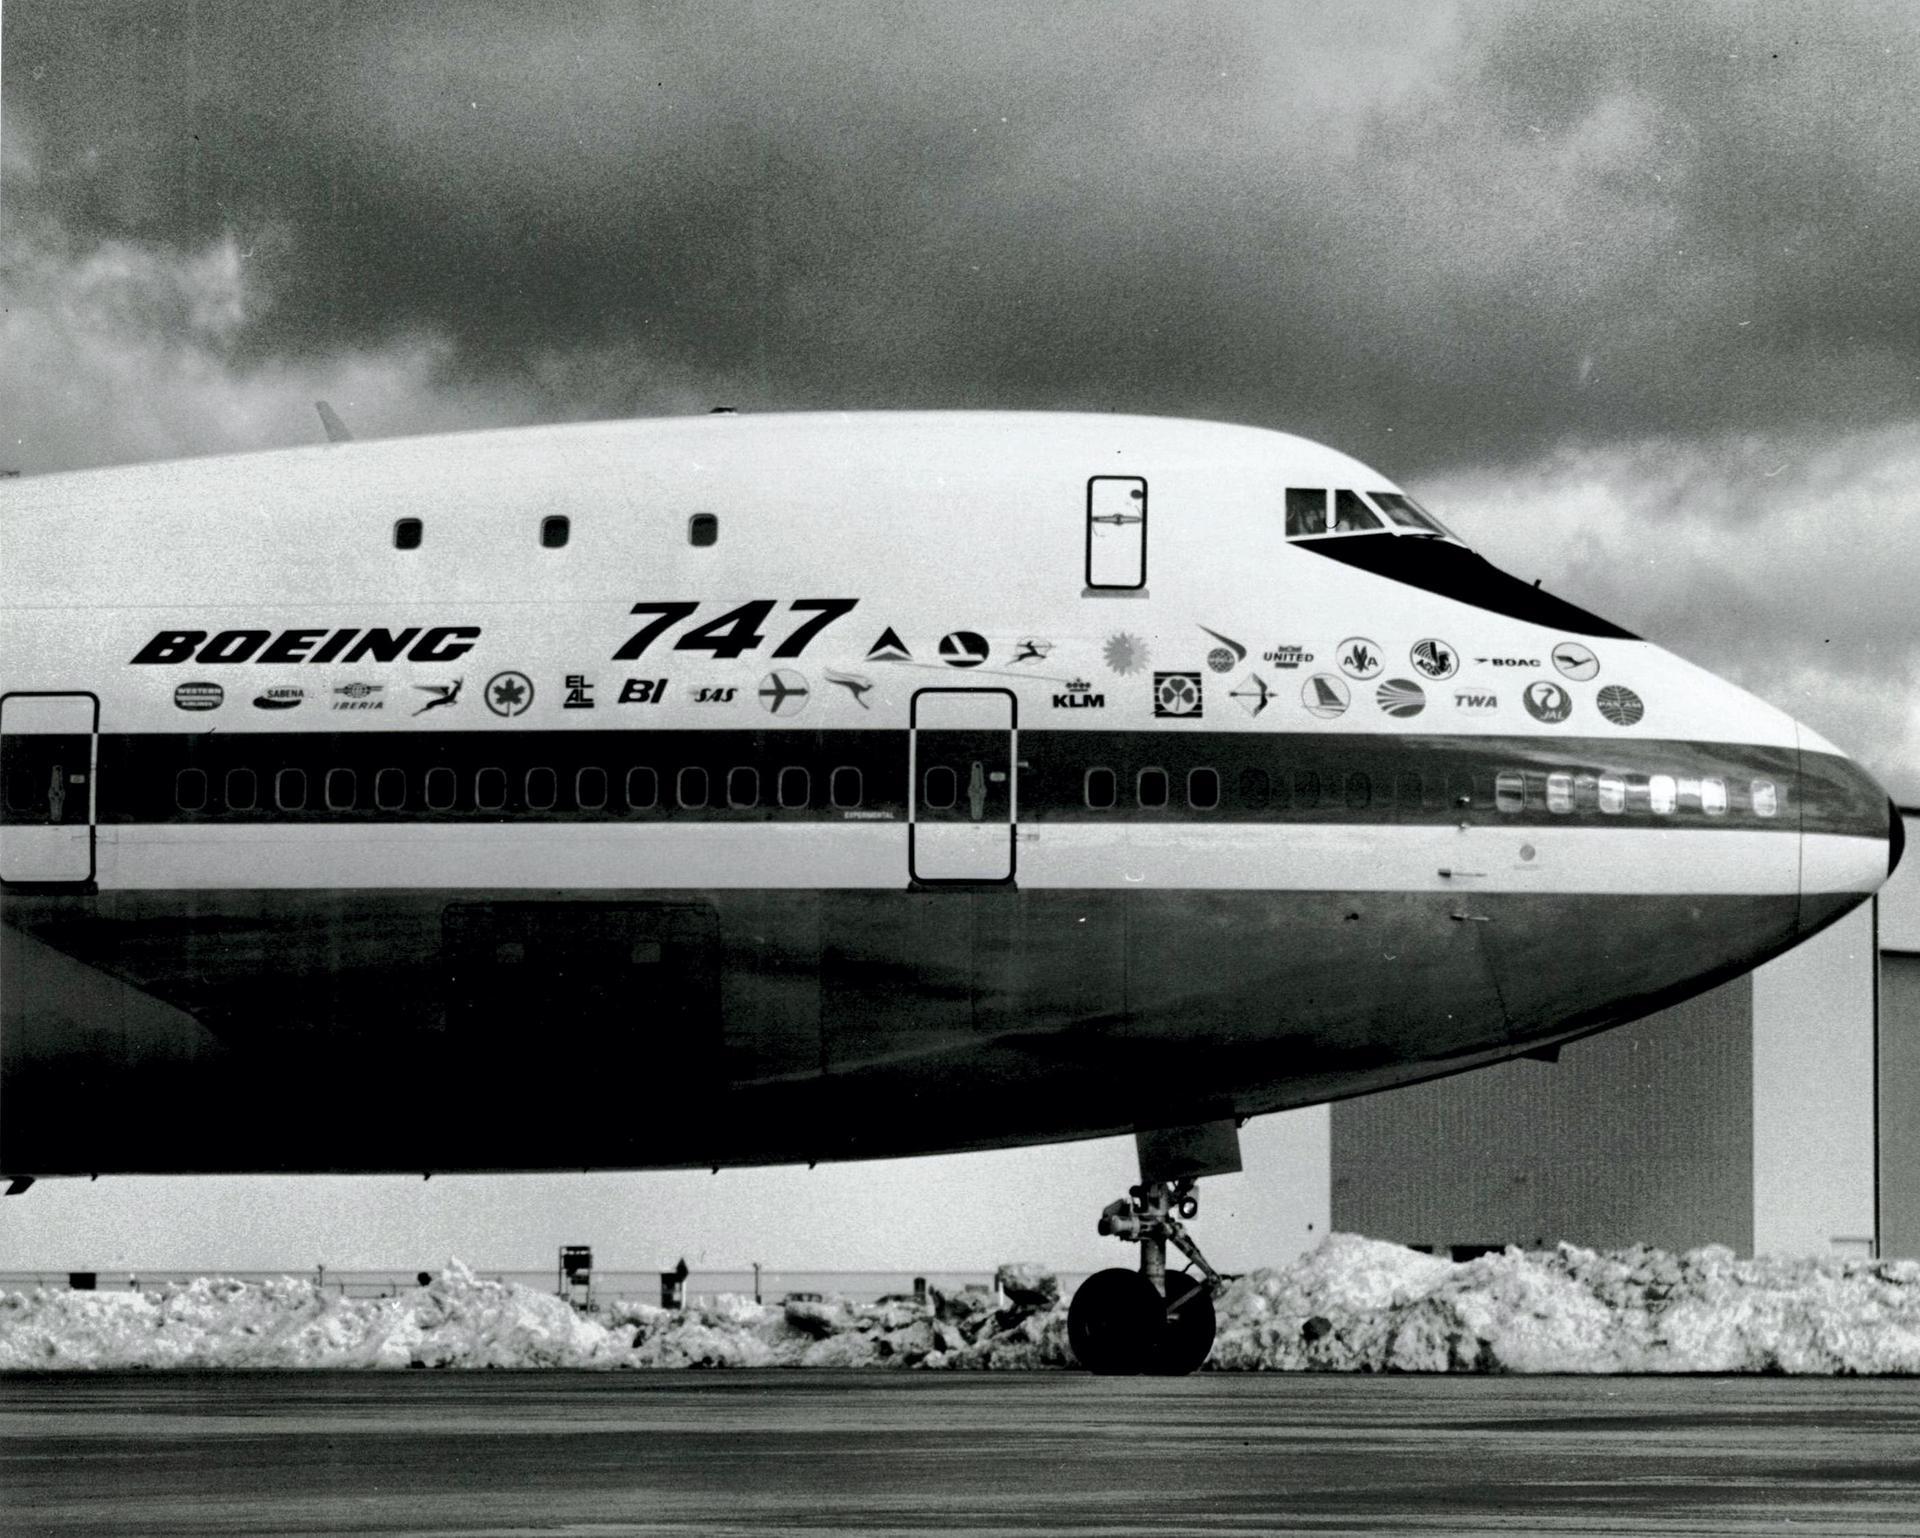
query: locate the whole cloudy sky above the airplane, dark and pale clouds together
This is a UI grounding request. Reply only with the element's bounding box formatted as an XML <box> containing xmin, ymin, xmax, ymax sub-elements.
<box><xmin>0</xmin><ymin>0</ymin><xmax>1920</xmax><ymax>1263</ymax></box>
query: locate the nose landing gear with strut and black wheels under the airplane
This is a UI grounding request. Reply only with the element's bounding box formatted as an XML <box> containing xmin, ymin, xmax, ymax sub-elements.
<box><xmin>1068</xmin><ymin>1121</ymin><xmax>1240</xmax><ymax>1377</ymax></box>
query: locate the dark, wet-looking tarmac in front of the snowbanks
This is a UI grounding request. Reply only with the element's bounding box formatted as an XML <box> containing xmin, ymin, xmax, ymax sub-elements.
<box><xmin>0</xmin><ymin>1371</ymin><xmax>1920</xmax><ymax>1538</ymax></box>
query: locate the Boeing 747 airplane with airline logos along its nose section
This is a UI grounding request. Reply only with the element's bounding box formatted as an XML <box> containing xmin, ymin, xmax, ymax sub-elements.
<box><xmin>0</xmin><ymin>413</ymin><xmax>1901</xmax><ymax>1371</ymax></box>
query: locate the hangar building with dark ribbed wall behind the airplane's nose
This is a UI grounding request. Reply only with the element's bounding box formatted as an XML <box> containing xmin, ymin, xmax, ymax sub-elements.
<box><xmin>1329</xmin><ymin>808</ymin><xmax>1920</xmax><ymax>1258</ymax></box>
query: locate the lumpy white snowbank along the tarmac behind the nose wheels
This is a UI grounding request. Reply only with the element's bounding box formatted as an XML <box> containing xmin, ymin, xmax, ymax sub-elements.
<box><xmin>11</xmin><ymin>1235</ymin><xmax>1920</xmax><ymax>1373</ymax></box>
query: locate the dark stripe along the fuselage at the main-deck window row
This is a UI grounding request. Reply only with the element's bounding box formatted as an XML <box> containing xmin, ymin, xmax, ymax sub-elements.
<box><xmin>4</xmin><ymin>728</ymin><xmax>1866</xmax><ymax>831</ymax></box>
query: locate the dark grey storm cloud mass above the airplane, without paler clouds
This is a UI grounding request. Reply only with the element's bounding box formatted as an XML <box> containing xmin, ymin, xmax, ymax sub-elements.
<box><xmin>4</xmin><ymin>0</ymin><xmax>1920</xmax><ymax>472</ymax></box>
